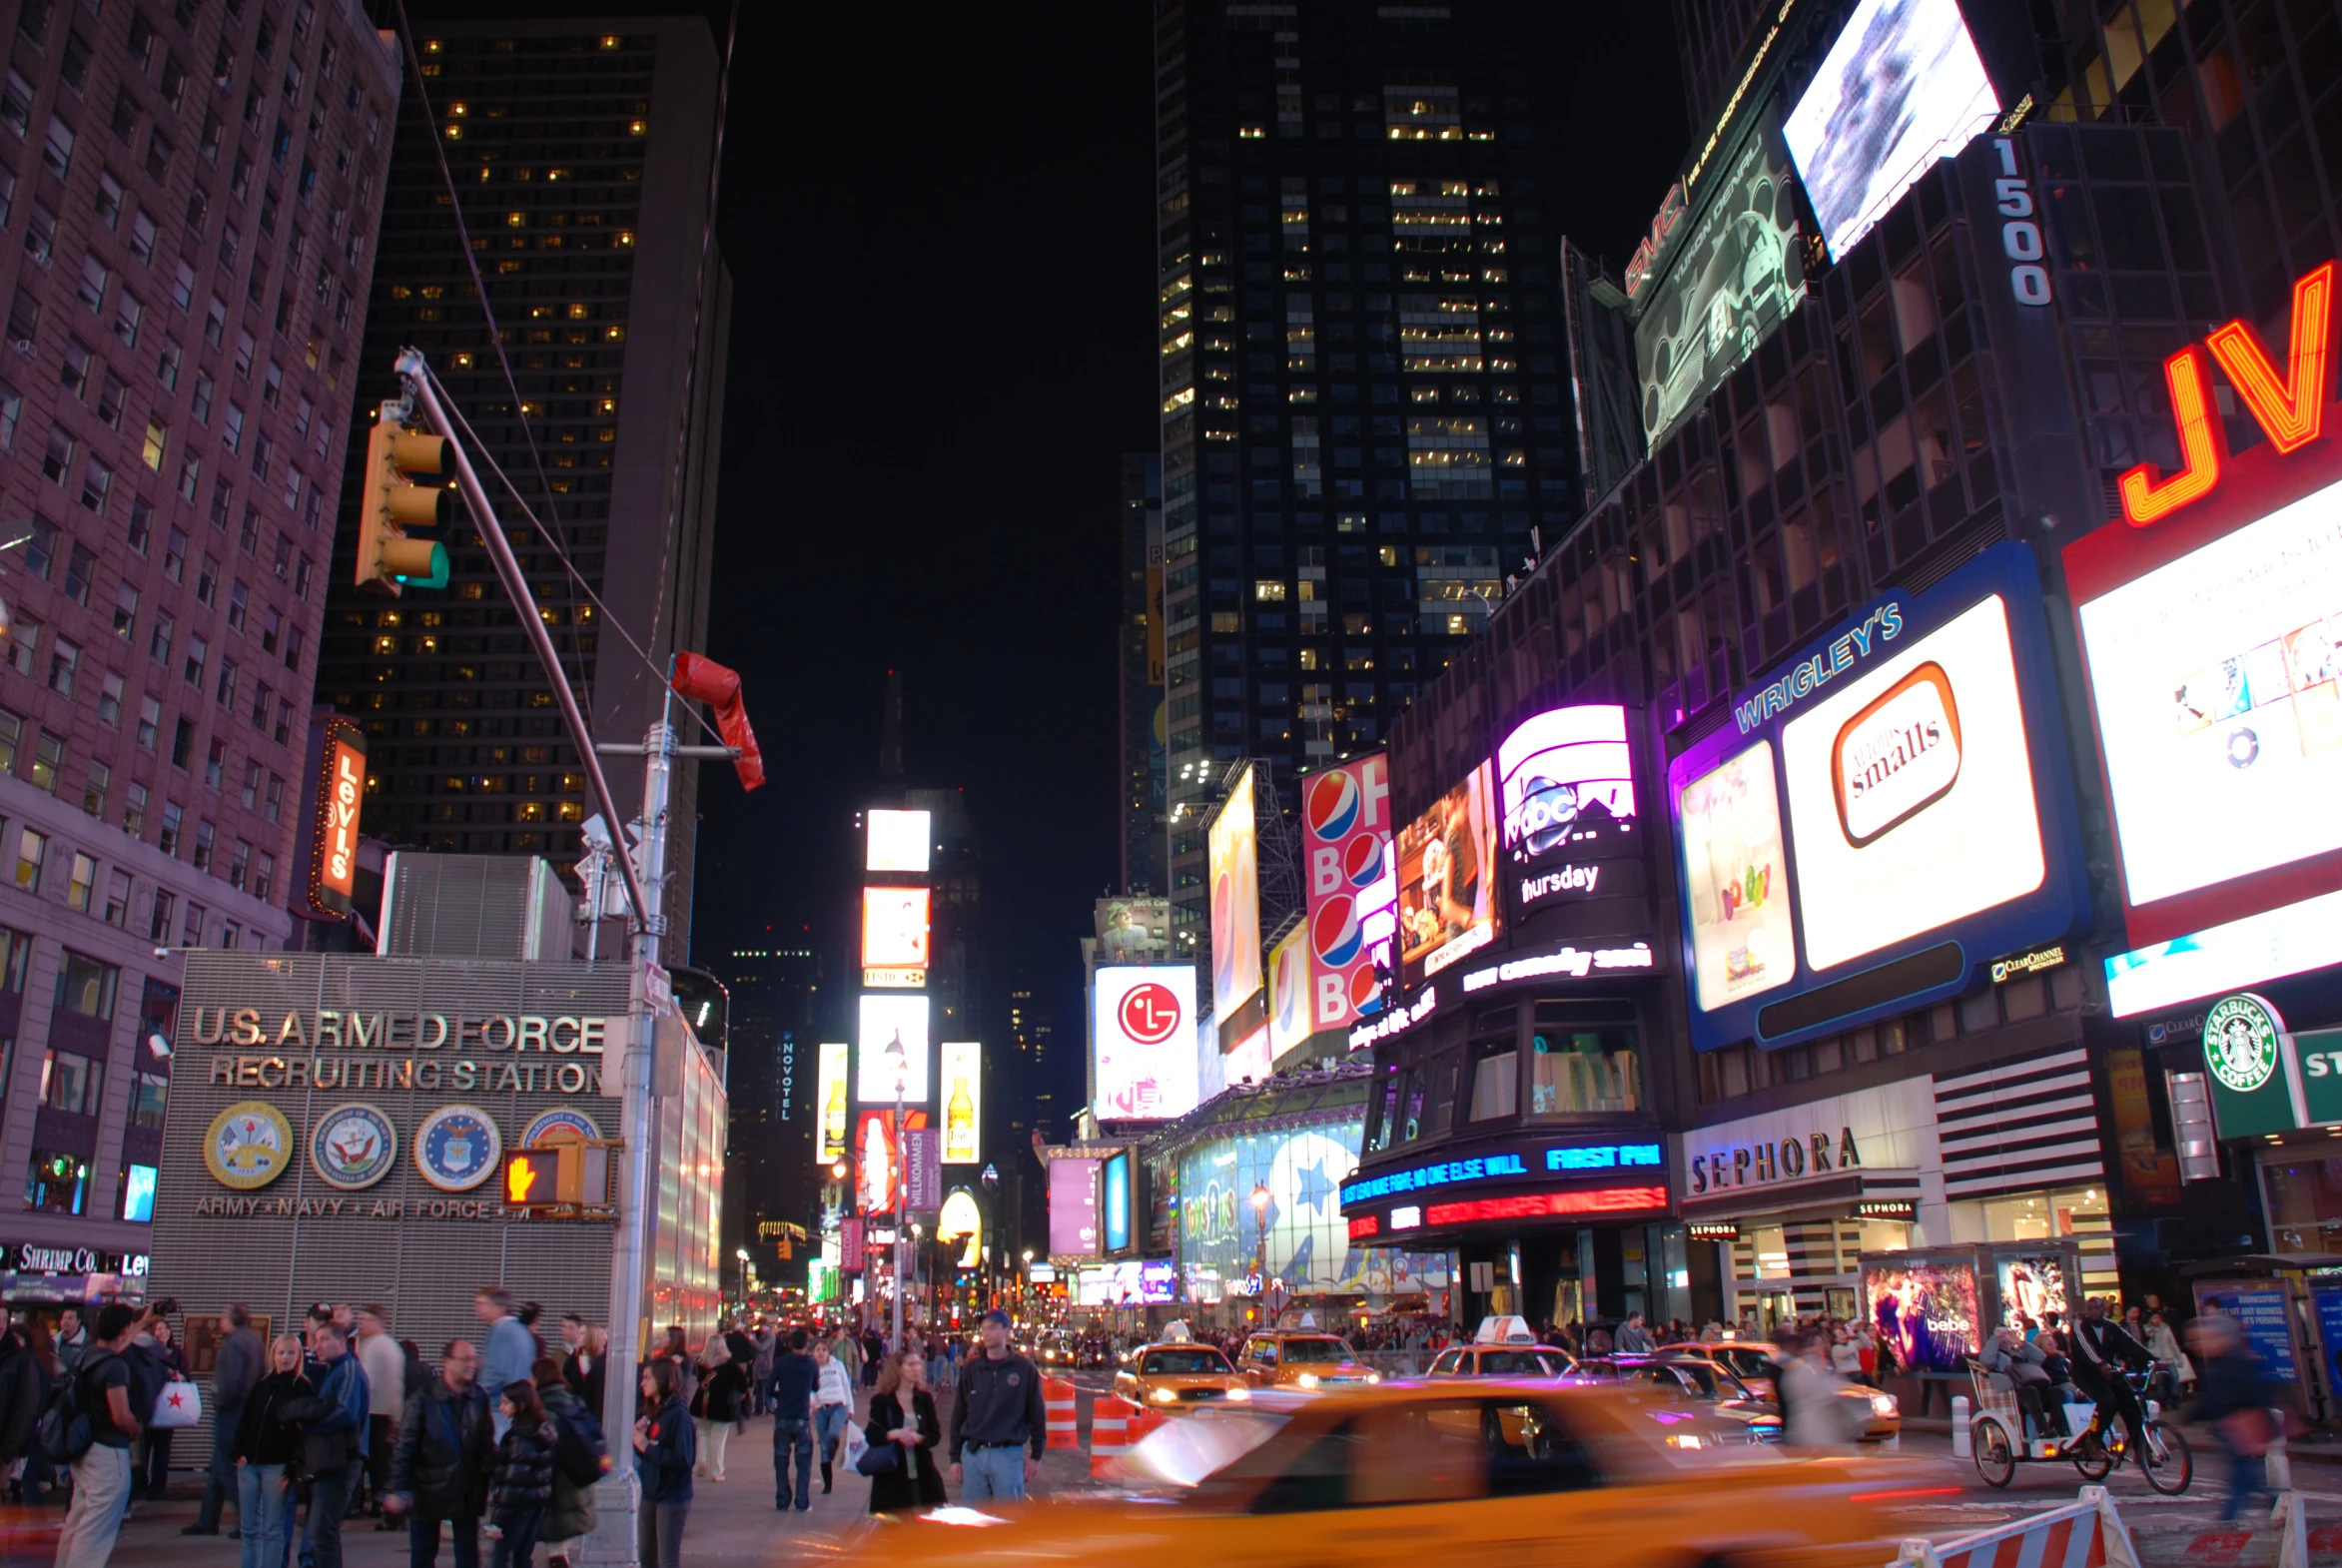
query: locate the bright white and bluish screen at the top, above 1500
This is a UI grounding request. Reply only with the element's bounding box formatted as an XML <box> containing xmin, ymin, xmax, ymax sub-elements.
<box><xmin>1783</xmin><ymin>0</ymin><xmax>2000</xmax><ymax>258</ymax></box>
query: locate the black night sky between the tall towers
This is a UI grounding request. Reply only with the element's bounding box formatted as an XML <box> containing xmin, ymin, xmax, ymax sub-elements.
<box><xmin>409</xmin><ymin>0</ymin><xmax>1689</xmax><ymax>1119</ymax></box>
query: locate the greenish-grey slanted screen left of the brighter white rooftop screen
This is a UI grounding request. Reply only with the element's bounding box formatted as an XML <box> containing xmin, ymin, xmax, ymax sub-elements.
<box><xmin>1635</xmin><ymin>110</ymin><xmax>1806</xmax><ymax>447</ymax></box>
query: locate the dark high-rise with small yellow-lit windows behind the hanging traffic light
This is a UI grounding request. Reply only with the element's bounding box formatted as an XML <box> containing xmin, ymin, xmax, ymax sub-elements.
<box><xmin>319</xmin><ymin>21</ymin><xmax>728</xmax><ymax>957</ymax></box>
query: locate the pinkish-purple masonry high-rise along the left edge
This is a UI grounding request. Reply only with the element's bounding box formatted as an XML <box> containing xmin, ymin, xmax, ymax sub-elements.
<box><xmin>0</xmin><ymin>0</ymin><xmax>398</xmax><ymax>1273</ymax></box>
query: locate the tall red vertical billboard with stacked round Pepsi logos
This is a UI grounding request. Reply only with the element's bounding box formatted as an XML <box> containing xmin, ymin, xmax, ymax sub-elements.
<box><xmin>1302</xmin><ymin>751</ymin><xmax>1398</xmax><ymax>1035</ymax></box>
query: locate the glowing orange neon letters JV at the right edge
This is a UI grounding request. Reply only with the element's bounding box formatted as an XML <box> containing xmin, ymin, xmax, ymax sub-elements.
<box><xmin>2122</xmin><ymin>262</ymin><xmax>2335</xmax><ymax>529</ymax></box>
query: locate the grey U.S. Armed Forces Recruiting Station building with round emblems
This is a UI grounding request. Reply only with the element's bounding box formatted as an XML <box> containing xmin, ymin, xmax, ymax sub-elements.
<box><xmin>150</xmin><ymin>926</ymin><xmax>724</xmax><ymax>1385</ymax></box>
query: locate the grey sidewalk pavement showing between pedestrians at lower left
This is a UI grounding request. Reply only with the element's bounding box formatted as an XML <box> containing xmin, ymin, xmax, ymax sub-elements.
<box><xmin>27</xmin><ymin>1418</ymin><xmax>1089</xmax><ymax>1568</ymax></box>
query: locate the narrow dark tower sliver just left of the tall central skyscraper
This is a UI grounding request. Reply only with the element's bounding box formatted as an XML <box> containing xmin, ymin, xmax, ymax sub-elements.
<box><xmin>1115</xmin><ymin>451</ymin><xmax>1169</xmax><ymax>894</ymax></box>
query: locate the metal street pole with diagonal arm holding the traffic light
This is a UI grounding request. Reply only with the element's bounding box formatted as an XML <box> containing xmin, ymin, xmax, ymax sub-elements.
<box><xmin>398</xmin><ymin>349</ymin><xmax>740</xmax><ymax>1568</ymax></box>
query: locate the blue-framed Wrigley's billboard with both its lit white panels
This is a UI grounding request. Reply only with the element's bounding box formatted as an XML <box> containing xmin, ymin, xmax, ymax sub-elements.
<box><xmin>1668</xmin><ymin>543</ymin><xmax>2086</xmax><ymax>1051</ymax></box>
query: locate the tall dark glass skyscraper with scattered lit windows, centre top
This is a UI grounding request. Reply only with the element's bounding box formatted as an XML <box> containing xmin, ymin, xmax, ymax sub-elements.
<box><xmin>1155</xmin><ymin>0</ymin><xmax>1579</xmax><ymax>969</ymax></box>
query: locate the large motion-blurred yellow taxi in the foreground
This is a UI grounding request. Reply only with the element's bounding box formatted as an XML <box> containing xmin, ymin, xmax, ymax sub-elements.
<box><xmin>834</xmin><ymin>1381</ymin><xmax>1909</xmax><ymax>1568</ymax></box>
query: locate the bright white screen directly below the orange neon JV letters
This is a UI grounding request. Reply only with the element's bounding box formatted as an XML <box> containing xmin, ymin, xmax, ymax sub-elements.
<box><xmin>2079</xmin><ymin>472</ymin><xmax>2342</xmax><ymax>926</ymax></box>
